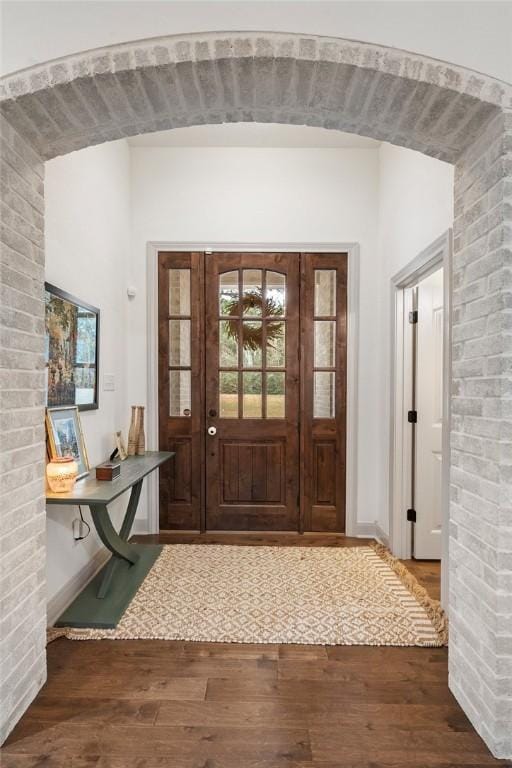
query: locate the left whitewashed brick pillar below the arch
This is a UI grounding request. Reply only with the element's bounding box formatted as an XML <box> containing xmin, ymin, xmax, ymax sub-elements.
<box><xmin>0</xmin><ymin>114</ymin><xmax>46</xmax><ymax>743</ymax></box>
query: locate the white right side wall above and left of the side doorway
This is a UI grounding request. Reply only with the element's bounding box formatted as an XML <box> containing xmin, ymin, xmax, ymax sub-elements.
<box><xmin>377</xmin><ymin>144</ymin><xmax>454</xmax><ymax>533</ymax></box>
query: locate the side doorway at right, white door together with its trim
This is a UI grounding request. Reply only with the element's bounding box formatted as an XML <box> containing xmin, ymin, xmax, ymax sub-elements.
<box><xmin>390</xmin><ymin>232</ymin><xmax>451</xmax><ymax>605</ymax></box>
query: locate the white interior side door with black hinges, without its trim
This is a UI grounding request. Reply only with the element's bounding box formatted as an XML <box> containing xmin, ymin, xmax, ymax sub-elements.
<box><xmin>414</xmin><ymin>269</ymin><xmax>444</xmax><ymax>560</ymax></box>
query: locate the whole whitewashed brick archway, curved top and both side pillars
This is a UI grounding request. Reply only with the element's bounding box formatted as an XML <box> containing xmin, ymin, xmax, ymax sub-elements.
<box><xmin>0</xmin><ymin>33</ymin><xmax>512</xmax><ymax>756</ymax></box>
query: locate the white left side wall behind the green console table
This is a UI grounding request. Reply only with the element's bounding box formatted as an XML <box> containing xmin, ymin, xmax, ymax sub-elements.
<box><xmin>45</xmin><ymin>140</ymin><xmax>130</xmax><ymax>612</ymax></box>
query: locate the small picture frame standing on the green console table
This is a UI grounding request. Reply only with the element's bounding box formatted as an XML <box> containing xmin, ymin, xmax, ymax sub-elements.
<box><xmin>46</xmin><ymin>405</ymin><xmax>90</xmax><ymax>480</ymax></box>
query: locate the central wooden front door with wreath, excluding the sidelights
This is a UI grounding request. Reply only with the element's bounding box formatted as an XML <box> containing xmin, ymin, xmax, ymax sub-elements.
<box><xmin>205</xmin><ymin>253</ymin><xmax>300</xmax><ymax>531</ymax></box>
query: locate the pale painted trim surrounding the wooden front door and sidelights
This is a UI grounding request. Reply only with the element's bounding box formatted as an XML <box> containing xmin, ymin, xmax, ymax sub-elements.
<box><xmin>144</xmin><ymin>241</ymin><xmax>360</xmax><ymax>536</ymax></box>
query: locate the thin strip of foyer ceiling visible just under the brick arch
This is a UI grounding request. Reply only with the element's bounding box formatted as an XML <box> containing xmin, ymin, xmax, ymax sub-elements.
<box><xmin>128</xmin><ymin>123</ymin><xmax>381</xmax><ymax>149</ymax></box>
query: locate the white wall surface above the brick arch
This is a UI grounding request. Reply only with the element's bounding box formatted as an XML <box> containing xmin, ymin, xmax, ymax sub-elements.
<box><xmin>1</xmin><ymin>0</ymin><xmax>512</xmax><ymax>81</ymax></box>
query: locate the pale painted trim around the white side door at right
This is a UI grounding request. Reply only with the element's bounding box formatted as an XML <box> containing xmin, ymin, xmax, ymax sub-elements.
<box><xmin>383</xmin><ymin>229</ymin><xmax>452</xmax><ymax>608</ymax></box>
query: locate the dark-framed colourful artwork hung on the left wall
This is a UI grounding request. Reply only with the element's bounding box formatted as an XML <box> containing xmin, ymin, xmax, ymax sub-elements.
<box><xmin>44</xmin><ymin>283</ymin><xmax>100</xmax><ymax>411</ymax></box>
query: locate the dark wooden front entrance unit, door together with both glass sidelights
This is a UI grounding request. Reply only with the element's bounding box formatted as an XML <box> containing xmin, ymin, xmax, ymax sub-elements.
<box><xmin>159</xmin><ymin>252</ymin><xmax>347</xmax><ymax>532</ymax></box>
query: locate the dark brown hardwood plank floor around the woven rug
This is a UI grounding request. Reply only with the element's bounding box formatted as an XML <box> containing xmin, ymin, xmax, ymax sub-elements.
<box><xmin>0</xmin><ymin>534</ymin><xmax>510</xmax><ymax>768</ymax></box>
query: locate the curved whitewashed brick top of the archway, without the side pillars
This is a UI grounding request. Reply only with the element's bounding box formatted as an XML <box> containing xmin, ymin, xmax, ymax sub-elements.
<box><xmin>1</xmin><ymin>32</ymin><xmax>512</xmax><ymax>162</ymax></box>
